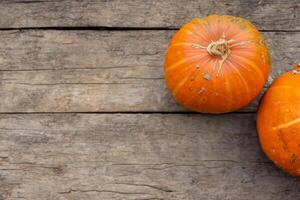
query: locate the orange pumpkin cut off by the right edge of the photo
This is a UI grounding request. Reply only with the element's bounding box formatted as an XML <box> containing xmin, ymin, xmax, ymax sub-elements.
<box><xmin>257</xmin><ymin>64</ymin><xmax>300</xmax><ymax>176</ymax></box>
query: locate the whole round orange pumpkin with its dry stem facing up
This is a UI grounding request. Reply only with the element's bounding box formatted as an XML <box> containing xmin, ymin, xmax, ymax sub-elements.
<box><xmin>164</xmin><ymin>15</ymin><xmax>270</xmax><ymax>113</ymax></box>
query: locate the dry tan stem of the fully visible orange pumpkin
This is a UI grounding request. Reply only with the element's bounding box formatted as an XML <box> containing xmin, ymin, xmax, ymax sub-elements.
<box><xmin>206</xmin><ymin>38</ymin><xmax>230</xmax><ymax>76</ymax></box>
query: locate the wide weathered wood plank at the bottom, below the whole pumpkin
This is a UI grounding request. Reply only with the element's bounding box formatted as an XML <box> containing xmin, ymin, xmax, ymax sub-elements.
<box><xmin>0</xmin><ymin>114</ymin><xmax>300</xmax><ymax>200</ymax></box>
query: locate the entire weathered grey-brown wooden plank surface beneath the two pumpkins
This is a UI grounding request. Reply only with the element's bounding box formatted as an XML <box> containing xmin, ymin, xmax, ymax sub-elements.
<box><xmin>0</xmin><ymin>0</ymin><xmax>300</xmax><ymax>200</ymax></box>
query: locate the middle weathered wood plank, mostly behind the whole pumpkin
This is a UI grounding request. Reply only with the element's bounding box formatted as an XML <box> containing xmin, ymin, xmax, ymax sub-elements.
<box><xmin>0</xmin><ymin>31</ymin><xmax>300</xmax><ymax>112</ymax></box>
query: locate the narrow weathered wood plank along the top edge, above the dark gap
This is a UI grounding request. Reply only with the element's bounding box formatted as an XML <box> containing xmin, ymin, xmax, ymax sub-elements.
<box><xmin>0</xmin><ymin>0</ymin><xmax>300</xmax><ymax>30</ymax></box>
